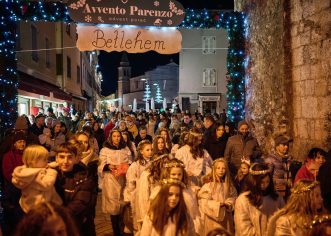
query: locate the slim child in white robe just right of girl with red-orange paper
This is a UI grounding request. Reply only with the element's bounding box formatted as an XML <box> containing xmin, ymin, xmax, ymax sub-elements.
<box><xmin>124</xmin><ymin>140</ymin><xmax>153</xmax><ymax>230</ymax></box>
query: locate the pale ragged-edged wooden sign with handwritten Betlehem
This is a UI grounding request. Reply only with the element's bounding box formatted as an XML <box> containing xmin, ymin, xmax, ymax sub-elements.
<box><xmin>77</xmin><ymin>25</ymin><xmax>182</xmax><ymax>54</ymax></box>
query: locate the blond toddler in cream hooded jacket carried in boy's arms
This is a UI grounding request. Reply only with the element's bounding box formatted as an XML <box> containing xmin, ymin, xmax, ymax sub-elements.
<box><xmin>12</xmin><ymin>145</ymin><xmax>62</xmax><ymax>213</ymax></box>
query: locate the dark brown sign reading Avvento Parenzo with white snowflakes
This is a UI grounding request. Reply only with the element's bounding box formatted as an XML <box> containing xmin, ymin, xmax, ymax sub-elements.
<box><xmin>67</xmin><ymin>0</ymin><xmax>185</xmax><ymax>27</ymax></box>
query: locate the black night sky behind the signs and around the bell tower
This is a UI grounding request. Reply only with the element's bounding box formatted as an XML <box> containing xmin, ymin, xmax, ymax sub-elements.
<box><xmin>99</xmin><ymin>0</ymin><xmax>233</xmax><ymax>96</ymax></box>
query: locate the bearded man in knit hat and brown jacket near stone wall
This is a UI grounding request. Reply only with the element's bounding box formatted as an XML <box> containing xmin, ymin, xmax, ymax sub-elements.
<box><xmin>224</xmin><ymin>120</ymin><xmax>262</xmax><ymax>176</ymax></box>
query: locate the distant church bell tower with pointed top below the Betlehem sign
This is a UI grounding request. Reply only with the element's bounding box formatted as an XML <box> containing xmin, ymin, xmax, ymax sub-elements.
<box><xmin>117</xmin><ymin>52</ymin><xmax>131</xmax><ymax>107</ymax></box>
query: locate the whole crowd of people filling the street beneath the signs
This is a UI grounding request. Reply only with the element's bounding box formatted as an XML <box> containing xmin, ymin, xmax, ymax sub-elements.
<box><xmin>0</xmin><ymin>108</ymin><xmax>331</xmax><ymax>236</ymax></box>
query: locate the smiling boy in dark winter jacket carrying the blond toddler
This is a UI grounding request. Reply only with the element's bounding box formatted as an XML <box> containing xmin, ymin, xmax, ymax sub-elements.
<box><xmin>55</xmin><ymin>142</ymin><xmax>97</xmax><ymax>236</ymax></box>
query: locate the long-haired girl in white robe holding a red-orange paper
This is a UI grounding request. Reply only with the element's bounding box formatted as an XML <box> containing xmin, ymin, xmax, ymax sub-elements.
<box><xmin>98</xmin><ymin>129</ymin><xmax>131</xmax><ymax>235</ymax></box>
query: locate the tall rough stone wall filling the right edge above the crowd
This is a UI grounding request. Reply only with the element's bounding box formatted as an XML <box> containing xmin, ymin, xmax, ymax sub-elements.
<box><xmin>235</xmin><ymin>0</ymin><xmax>331</xmax><ymax>159</ymax></box>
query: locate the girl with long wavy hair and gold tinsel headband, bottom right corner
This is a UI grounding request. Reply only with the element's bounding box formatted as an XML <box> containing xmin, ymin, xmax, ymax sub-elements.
<box><xmin>268</xmin><ymin>180</ymin><xmax>323</xmax><ymax>236</ymax></box>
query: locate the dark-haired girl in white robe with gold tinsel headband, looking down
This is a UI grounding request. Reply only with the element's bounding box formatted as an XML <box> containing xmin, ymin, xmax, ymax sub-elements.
<box><xmin>234</xmin><ymin>163</ymin><xmax>284</xmax><ymax>236</ymax></box>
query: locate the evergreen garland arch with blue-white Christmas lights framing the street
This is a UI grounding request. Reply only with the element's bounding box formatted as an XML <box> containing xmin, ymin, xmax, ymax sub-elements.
<box><xmin>0</xmin><ymin>0</ymin><xmax>247</xmax><ymax>132</ymax></box>
